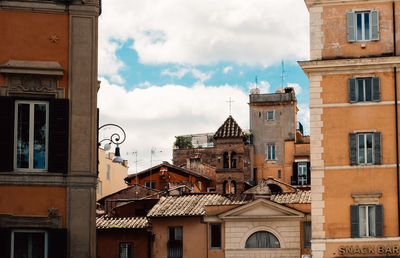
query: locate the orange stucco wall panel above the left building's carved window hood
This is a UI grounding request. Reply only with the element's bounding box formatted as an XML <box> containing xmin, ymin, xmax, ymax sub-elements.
<box><xmin>0</xmin><ymin>11</ymin><xmax>69</xmax><ymax>94</ymax></box>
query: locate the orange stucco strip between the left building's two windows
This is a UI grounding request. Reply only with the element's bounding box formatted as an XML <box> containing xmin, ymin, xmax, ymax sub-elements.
<box><xmin>0</xmin><ymin>186</ymin><xmax>67</xmax><ymax>227</ymax></box>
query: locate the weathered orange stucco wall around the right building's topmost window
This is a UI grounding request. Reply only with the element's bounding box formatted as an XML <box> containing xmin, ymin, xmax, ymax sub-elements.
<box><xmin>322</xmin><ymin>2</ymin><xmax>398</xmax><ymax>59</ymax></box>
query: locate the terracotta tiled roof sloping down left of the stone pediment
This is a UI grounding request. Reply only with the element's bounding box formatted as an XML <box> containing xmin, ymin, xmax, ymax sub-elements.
<box><xmin>147</xmin><ymin>194</ymin><xmax>246</xmax><ymax>217</ymax></box>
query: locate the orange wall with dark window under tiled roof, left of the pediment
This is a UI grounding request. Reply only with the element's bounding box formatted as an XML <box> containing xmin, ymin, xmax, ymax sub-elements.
<box><xmin>150</xmin><ymin>217</ymin><xmax>208</xmax><ymax>258</ymax></box>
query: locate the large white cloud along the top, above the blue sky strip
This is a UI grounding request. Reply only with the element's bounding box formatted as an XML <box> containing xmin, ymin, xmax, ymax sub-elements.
<box><xmin>99</xmin><ymin>0</ymin><xmax>309</xmax><ymax>75</ymax></box>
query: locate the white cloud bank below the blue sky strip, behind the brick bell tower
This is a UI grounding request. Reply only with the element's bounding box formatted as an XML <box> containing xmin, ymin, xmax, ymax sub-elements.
<box><xmin>98</xmin><ymin>78</ymin><xmax>249</xmax><ymax>172</ymax></box>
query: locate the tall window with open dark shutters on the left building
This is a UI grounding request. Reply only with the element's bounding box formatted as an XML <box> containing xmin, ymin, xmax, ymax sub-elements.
<box><xmin>0</xmin><ymin>96</ymin><xmax>69</xmax><ymax>173</ymax></box>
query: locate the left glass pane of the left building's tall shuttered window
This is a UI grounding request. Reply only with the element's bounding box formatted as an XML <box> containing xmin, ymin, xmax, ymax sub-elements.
<box><xmin>17</xmin><ymin>104</ymin><xmax>29</xmax><ymax>168</ymax></box>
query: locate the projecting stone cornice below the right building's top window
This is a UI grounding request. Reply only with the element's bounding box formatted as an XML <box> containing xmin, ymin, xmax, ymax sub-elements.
<box><xmin>298</xmin><ymin>56</ymin><xmax>400</xmax><ymax>76</ymax></box>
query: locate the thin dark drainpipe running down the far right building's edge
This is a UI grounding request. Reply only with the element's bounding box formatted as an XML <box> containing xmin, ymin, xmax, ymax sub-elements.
<box><xmin>392</xmin><ymin>1</ymin><xmax>400</xmax><ymax>236</ymax></box>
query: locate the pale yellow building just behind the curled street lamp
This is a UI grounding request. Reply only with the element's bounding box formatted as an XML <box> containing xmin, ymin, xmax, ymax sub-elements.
<box><xmin>96</xmin><ymin>148</ymin><xmax>128</xmax><ymax>200</ymax></box>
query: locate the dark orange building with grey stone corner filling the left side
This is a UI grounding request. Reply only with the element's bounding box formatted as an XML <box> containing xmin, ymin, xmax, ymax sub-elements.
<box><xmin>0</xmin><ymin>0</ymin><xmax>100</xmax><ymax>258</ymax></box>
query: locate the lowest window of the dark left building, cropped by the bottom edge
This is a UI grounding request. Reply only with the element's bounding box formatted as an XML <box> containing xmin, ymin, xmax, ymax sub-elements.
<box><xmin>11</xmin><ymin>230</ymin><xmax>47</xmax><ymax>258</ymax></box>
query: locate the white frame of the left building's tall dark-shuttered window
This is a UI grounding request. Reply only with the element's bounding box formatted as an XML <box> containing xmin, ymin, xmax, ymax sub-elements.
<box><xmin>14</xmin><ymin>100</ymin><xmax>49</xmax><ymax>172</ymax></box>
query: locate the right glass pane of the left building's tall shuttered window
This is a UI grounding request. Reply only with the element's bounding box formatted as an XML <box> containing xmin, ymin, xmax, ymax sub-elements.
<box><xmin>33</xmin><ymin>104</ymin><xmax>47</xmax><ymax>169</ymax></box>
